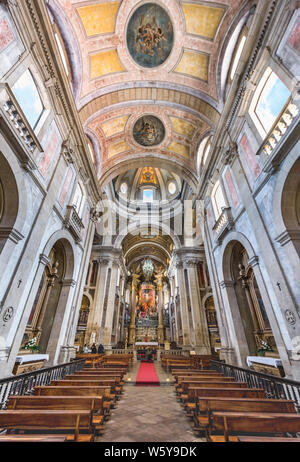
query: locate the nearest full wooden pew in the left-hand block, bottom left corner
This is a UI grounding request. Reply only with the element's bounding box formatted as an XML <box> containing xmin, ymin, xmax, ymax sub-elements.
<box><xmin>0</xmin><ymin>409</ymin><xmax>94</xmax><ymax>442</ymax></box>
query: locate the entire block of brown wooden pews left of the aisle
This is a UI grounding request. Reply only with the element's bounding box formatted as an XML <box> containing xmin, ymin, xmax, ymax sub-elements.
<box><xmin>0</xmin><ymin>358</ymin><xmax>129</xmax><ymax>442</ymax></box>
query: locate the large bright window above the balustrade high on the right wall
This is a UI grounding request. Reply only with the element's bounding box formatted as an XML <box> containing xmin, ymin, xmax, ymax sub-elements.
<box><xmin>249</xmin><ymin>67</ymin><xmax>291</xmax><ymax>139</ymax></box>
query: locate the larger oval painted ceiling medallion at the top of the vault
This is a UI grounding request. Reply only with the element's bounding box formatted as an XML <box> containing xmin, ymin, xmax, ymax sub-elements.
<box><xmin>127</xmin><ymin>3</ymin><xmax>174</xmax><ymax>68</ymax></box>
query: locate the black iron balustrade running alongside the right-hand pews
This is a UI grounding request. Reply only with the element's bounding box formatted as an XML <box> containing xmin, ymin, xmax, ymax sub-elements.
<box><xmin>211</xmin><ymin>361</ymin><xmax>300</xmax><ymax>413</ymax></box>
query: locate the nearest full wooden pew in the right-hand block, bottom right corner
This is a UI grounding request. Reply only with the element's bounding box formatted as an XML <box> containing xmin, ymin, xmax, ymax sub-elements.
<box><xmin>209</xmin><ymin>411</ymin><xmax>300</xmax><ymax>442</ymax></box>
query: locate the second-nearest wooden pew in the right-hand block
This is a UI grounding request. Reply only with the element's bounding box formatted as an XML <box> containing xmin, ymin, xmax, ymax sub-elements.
<box><xmin>194</xmin><ymin>397</ymin><xmax>296</xmax><ymax>434</ymax></box>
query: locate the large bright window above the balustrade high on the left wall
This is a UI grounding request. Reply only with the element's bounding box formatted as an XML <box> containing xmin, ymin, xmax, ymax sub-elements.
<box><xmin>12</xmin><ymin>69</ymin><xmax>44</xmax><ymax>129</ymax></box>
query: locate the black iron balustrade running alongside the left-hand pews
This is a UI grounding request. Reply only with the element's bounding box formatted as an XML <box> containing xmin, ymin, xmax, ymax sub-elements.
<box><xmin>0</xmin><ymin>359</ymin><xmax>85</xmax><ymax>410</ymax></box>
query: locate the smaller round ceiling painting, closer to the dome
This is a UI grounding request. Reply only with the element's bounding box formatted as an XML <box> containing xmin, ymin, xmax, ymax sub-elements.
<box><xmin>133</xmin><ymin>115</ymin><xmax>166</xmax><ymax>147</ymax></box>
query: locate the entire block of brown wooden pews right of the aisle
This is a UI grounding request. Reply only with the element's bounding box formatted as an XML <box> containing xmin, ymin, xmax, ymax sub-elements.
<box><xmin>171</xmin><ymin>362</ymin><xmax>300</xmax><ymax>442</ymax></box>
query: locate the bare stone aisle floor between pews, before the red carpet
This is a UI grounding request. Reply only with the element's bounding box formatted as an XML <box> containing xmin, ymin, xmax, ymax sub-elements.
<box><xmin>96</xmin><ymin>385</ymin><xmax>206</xmax><ymax>443</ymax></box>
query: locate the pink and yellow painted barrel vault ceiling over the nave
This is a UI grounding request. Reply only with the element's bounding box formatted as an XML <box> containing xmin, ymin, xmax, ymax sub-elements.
<box><xmin>48</xmin><ymin>0</ymin><xmax>243</xmax><ymax>189</ymax></box>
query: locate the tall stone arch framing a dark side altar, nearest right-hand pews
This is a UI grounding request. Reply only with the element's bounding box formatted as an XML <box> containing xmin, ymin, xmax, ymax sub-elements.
<box><xmin>220</xmin><ymin>232</ymin><xmax>286</xmax><ymax>366</ymax></box>
